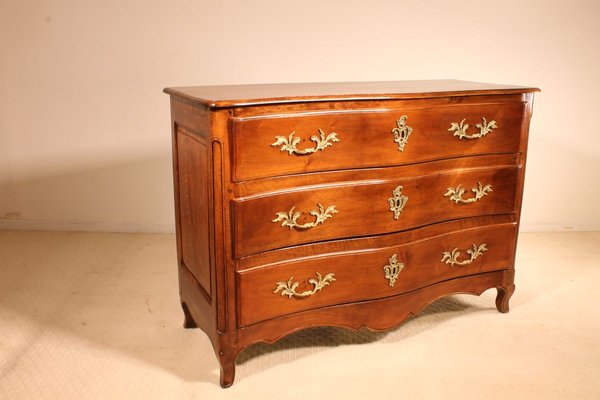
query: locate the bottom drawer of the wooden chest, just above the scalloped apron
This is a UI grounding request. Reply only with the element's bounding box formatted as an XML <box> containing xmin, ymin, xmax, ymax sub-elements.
<box><xmin>237</xmin><ymin>223</ymin><xmax>517</xmax><ymax>326</ymax></box>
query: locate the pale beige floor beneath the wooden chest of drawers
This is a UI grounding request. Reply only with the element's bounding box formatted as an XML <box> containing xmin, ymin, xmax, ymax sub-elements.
<box><xmin>0</xmin><ymin>231</ymin><xmax>600</xmax><ymax>400</ymax></box>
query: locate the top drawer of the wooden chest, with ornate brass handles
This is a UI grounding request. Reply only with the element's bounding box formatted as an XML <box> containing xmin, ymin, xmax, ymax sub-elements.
<box><xmin>231</xmin><ymin>102</ymin><xmax>524</xmax><ymax>181</ymax></box>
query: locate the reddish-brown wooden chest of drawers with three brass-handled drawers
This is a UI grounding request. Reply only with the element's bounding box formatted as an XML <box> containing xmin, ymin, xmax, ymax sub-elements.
<box><xmin>165</xmin><ymin>80</ymin><xmax>537</xmax><ymax>387</ymax></box>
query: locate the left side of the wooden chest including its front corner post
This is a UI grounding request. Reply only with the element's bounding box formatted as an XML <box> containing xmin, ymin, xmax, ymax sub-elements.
<box><xmin>171</xmin><ymin>97</ymin><xmax>237</xmax><ymax>372</ymax></box>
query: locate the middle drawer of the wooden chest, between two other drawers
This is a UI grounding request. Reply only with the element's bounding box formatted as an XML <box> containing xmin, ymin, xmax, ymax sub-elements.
<box><xmin>232</xmin><ymin>165</ymin><xmax>518</xmax><ymax>258</ymax></box>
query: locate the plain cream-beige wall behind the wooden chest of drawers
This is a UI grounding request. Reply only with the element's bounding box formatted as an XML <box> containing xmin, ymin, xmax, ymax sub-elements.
<box><xmin>0</xmin><ymin>0</ymin><xmax>600</xmax><ymax>231</ymax></box>
